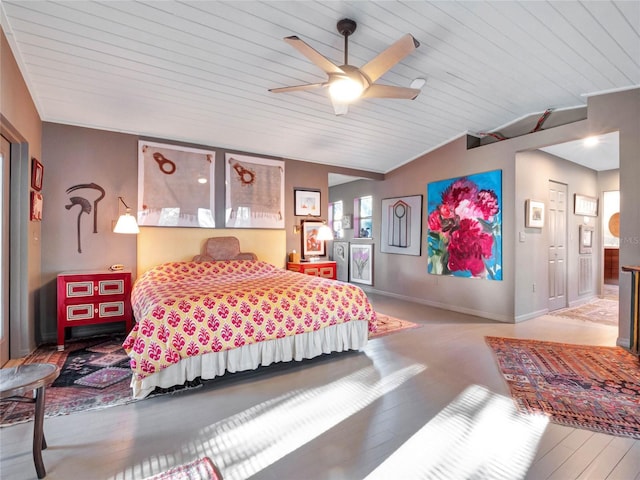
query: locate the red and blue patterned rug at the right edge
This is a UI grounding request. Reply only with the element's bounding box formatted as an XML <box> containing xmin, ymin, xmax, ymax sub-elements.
<box><xmin>486</xmin><ymin>337</ymin><xmax>640</xmax><ymax>440</ymax></box>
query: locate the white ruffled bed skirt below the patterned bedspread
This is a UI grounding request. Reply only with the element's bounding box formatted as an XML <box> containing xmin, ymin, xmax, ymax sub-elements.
<box><xmin>131</xmin><ymin>320</ymin><xmax>369</xmax><ymax>399</ymax></box>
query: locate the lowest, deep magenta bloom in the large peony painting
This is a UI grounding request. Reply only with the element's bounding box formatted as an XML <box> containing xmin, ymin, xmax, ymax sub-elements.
<box><xmin>448</xmin><ymin>219</ymin><xmax>493</xmax><ymax>276</ymax></box>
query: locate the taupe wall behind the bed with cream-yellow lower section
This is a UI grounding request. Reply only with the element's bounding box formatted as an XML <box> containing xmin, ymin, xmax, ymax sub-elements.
<box><xmin>39</xmin><ymin>122</ymin><xmax>381</xmax><ymax>340</ymax></box>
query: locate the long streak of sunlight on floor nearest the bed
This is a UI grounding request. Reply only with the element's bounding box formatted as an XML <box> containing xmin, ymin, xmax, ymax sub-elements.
<box><xmin>116</xmin><ymin>364</ymin><xmax>426</xmax><ymax>480</ymax></box>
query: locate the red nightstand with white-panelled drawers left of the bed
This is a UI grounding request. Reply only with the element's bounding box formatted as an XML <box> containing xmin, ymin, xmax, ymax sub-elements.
<box><xmin>58</xmin><ymin>270</ymin><xmax>133</xmax><ymax>350</ymax></box>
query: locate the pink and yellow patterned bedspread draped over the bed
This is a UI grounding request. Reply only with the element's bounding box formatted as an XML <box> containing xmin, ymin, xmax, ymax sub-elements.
<box><xmin>123</xmin><ymin>260</ymin><xmax>376</xmax><ymax>380</ymax></box>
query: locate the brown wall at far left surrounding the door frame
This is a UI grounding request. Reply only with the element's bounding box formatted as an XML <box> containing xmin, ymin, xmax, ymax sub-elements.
<box><xmin>0</xmin><ymin>28</ymin><xmax>42</xmax><ymax>358</ymax></box>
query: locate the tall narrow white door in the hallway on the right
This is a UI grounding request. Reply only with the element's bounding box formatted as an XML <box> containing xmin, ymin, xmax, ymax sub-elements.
<box><xmin>547</xmin><ymin>181</ymin><xmax>567</xmax><ymax>311</ymax></box>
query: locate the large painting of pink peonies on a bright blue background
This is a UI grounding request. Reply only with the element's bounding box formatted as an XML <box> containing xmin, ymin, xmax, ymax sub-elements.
<box><xmin>427</xmin><ymin>170</ymin><xmax>502</xmax><ymax>280</ymax></box>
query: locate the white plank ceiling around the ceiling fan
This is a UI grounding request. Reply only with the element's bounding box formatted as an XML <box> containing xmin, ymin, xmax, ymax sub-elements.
<box><xmin>0</xmin><ymin>0</ymin><xmax>640</xmax><ymax>172</ymax></box>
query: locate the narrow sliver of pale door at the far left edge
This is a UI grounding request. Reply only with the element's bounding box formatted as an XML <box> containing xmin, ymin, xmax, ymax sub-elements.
<box><xmin>0</xmin><ymin>137</ymin><xmax>11</xmax><ymax>366</ymax></box>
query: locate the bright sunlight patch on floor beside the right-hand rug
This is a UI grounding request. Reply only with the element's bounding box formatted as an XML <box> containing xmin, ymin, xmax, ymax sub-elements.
<box><xmin>366</xmin><ymin>385</ymin><xmax>549</xmax><ymax>480</ymax></box>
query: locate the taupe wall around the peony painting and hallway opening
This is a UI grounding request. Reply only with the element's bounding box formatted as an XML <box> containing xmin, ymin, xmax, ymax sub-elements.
<box><xmin>330</xmin><ymin>89</ymin><xmax>640</xmax><ymax>345</ymax></box>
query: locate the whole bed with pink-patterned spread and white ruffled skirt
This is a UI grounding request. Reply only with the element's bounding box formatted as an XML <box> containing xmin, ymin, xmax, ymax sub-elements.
<box><xmin>123</xmin><ymin>259</ymin><xmax>376</xmax><ymax>398</ymax></box>
